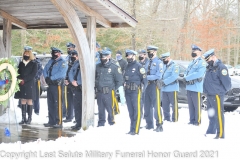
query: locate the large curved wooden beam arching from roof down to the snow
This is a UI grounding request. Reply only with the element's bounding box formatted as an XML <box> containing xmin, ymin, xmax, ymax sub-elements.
<box><xmin>51</xmin><ymin>0</ymin><xmax>95</xmax><ymax>130</ymax></box>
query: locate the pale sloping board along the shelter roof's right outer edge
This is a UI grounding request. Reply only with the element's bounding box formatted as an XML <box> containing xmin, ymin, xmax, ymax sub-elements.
<box><xmin>96</xmin><ymin>0</ymin><xmax>137</xmax><ymax>27</ymax></box>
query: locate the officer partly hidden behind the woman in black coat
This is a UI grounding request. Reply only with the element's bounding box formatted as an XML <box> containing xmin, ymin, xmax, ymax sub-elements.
<box><xmin>33</xmin><ymin>52</ymin><xmax>43</xmax><ymax>115</ymax></box>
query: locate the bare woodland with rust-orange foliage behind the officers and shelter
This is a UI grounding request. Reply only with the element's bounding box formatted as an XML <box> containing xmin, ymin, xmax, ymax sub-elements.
<box><xmin>6</xmin><ymin>0</ymin><xmax>240</xmax><ymax>66</ymax></box>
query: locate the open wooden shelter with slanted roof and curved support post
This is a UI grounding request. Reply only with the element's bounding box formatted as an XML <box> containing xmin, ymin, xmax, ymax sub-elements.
<box><xmin>0</xmin><ymin>0</ymin><xmax>137</xmax><ymax>129</ymax></box>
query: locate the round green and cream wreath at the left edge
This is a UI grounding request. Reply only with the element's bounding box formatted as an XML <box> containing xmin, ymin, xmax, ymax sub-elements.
<box><xmin>0</xmin><ymin>58</ymin><xmax>20</xmax><ymax>106</ymax></box>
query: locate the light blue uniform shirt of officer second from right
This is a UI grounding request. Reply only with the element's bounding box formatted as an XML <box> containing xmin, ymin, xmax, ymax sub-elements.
<box><xmin>184</xmin><ymin>57</ymin><xmax>206</xmax><ymax>93</ymax></box>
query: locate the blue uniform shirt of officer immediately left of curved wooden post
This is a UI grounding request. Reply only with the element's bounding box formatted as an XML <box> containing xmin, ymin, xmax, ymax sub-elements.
<box><xmin>68</xmin><ymin>60</ymin><xmax>82</xmax><ymax>85</ymax></box>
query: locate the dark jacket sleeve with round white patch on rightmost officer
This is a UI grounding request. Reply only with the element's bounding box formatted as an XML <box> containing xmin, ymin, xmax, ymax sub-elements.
<box><xmin>219</xmin><ymin>65</ymin><xmax>232</xmax><ymax>92</ymax></box>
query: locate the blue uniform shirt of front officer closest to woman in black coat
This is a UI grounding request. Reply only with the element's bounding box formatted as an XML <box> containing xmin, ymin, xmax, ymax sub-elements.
<box><xmin>43</xmin><ymin>56</ymin><xmax>68</xmax><ymax>80</ymax></box>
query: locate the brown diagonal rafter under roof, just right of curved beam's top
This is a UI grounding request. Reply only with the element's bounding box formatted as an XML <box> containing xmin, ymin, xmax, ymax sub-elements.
<box><xmin>70</xmin><ymin>0</ymin><xmax>111</xmax><ymax>28</ymax></box>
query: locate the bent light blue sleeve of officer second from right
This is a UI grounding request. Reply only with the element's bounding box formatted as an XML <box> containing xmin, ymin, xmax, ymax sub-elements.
<box><xmin>185</xmin><ymin>61</ymin><xmax>206</xmax><ymax>81</ymax></box>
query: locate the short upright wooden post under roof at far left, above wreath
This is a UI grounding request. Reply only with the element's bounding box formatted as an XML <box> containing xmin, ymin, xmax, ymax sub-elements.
<box><xmin>3</xmin><ymin>18</ymin><xmax>12</xmax><ymax>58</ymax></box>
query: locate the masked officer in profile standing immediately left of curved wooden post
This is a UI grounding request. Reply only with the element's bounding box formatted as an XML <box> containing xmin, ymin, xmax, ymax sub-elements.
<box><xmin>68</xmin><ymin>50</ymin><xmax>82</xmax><ymax>130</ymax></box>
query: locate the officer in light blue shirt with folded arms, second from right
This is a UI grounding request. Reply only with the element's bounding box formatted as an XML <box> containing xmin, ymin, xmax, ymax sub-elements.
<box><xmin>183</xmin><ymin>45</ymin><xmax>206</xmax><ymax>126</ymax></box>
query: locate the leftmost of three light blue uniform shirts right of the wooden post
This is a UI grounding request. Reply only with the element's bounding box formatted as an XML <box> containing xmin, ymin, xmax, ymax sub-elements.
<box><xmin>146</xmin><ymin>57</ymin><xmax>163</xmax><ymax>81</ymax></box>
